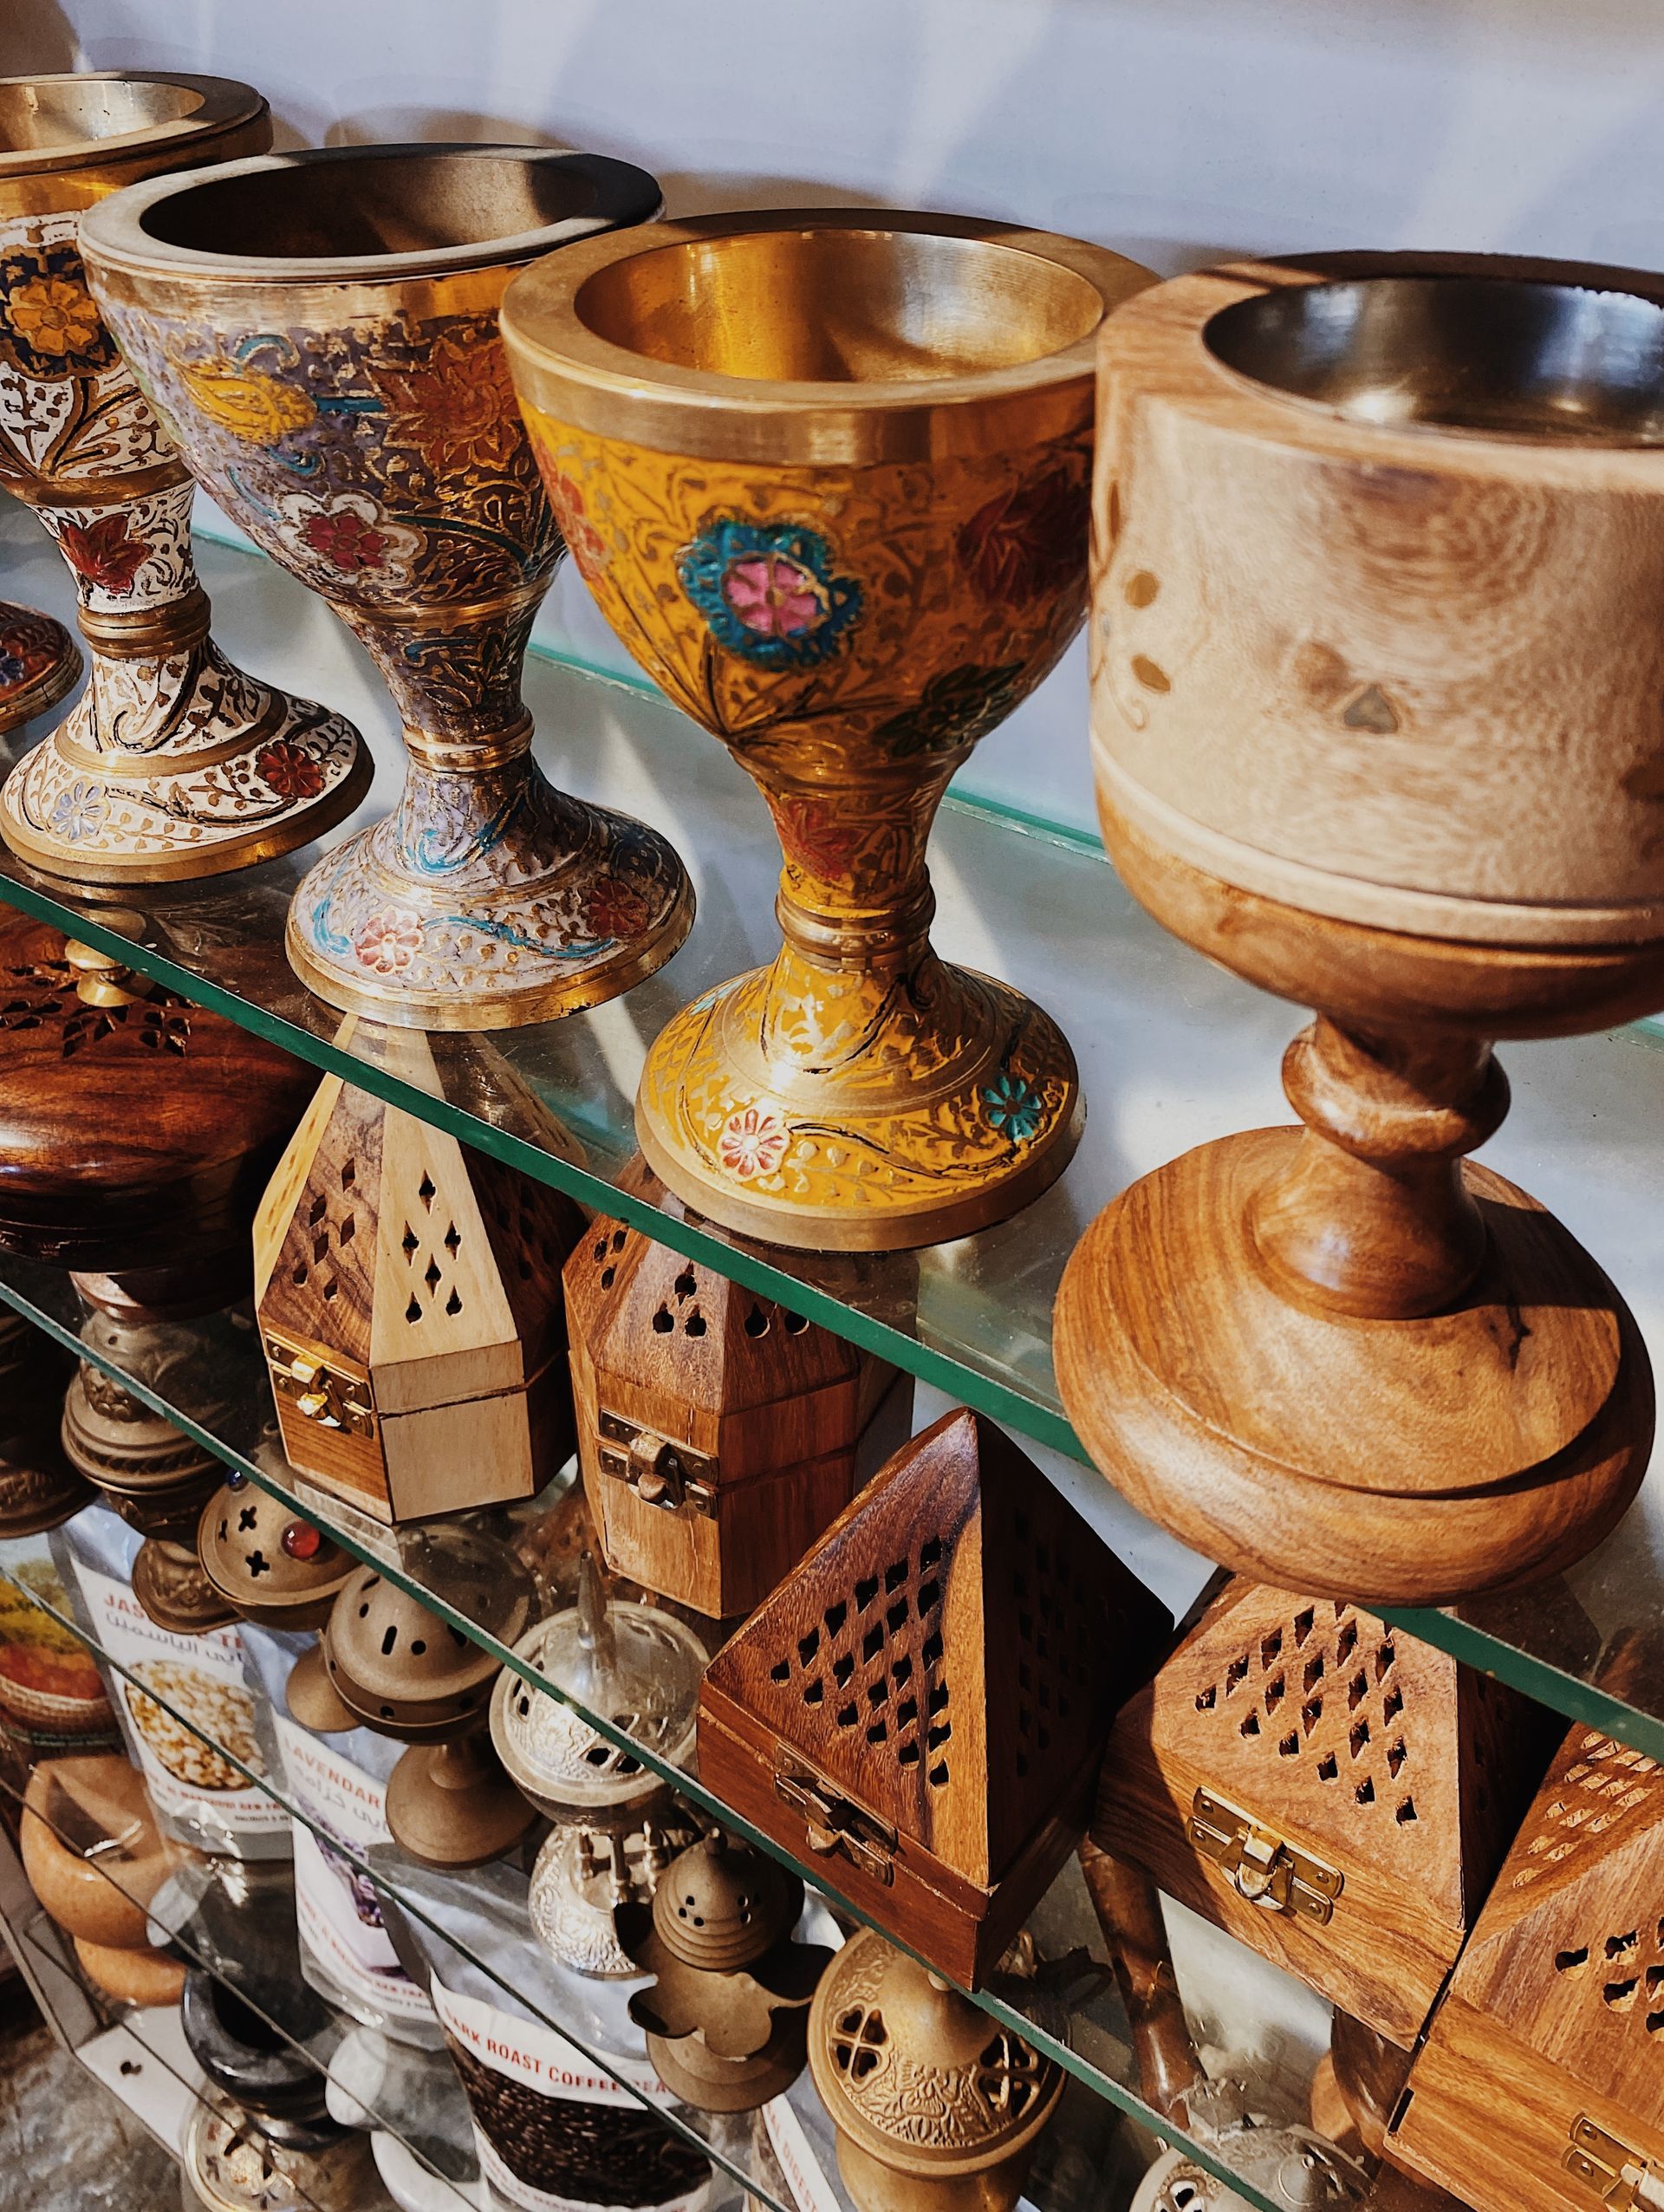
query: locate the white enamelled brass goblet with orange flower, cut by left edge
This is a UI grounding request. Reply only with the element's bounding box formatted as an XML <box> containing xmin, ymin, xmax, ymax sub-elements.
<box><xmin>0</xmin><ymin>68</ymin><xmax>369</xmax><ymax>882</ymax></box>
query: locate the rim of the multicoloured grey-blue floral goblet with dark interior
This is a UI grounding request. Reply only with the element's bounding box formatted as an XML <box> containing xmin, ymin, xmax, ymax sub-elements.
<box><xmin>81</xmin><ymin>140</ymin><xmax>664</xmax><ymax>290</ymax></box>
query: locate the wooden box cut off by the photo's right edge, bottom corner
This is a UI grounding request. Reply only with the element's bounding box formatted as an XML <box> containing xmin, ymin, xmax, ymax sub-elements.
<box><xmin>1388</xmin><ymin>1723</ymin><xmax>1664</xmax><ymax>2212</ymax></box>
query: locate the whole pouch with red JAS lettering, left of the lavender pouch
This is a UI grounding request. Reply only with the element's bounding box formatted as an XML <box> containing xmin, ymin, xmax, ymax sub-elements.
<box><xmin>51</xmin><ymin>1506</ymin><xmax>289</xmax><ymax>1858</ymax></box>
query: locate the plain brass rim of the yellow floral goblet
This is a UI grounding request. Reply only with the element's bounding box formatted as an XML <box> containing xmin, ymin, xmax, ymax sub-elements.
<box><xmin>503</xmin><ymin>208</ymin><xmax>1157</xmax><ymax>462</ymax></box>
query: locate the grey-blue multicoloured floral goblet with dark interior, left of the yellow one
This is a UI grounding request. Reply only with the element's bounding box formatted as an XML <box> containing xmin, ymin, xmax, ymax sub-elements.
<box><xmin>81</xmin><ymin>146</ymin><xmax>692</xmax><ymax>1029</ymax></box>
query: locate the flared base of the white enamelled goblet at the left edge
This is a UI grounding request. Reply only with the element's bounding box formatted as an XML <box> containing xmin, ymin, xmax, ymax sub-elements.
<box><xmin>0</xmin><ymin>646</ymin><xmax>372</xmax><ymax>882</ymax></box>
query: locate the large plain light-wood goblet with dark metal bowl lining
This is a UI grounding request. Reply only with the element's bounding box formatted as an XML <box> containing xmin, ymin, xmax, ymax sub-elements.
<box><xmin>1057</xmin><ymin>257</ymin><xmax>1664</xmax><ymax>1604</ymax></box>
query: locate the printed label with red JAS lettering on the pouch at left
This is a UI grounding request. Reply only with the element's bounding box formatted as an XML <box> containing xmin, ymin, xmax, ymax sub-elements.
<box><xmin>75</xmin><ymin>1562</ymin><xmax>289</xmax><ymax>1836</ymax></box>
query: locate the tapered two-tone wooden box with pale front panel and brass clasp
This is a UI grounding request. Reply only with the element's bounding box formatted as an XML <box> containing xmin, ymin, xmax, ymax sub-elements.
<box><xmin>255</xmin><ymin>1066</ymin><xmax>584</xmax><ymax>1522</ymax></box>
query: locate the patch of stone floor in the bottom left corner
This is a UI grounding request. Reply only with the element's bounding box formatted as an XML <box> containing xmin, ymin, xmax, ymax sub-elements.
<box><xmin>0</xmin><ymin>1977</ymin><xmax>179</xmax><ymax>2212</ymax></box>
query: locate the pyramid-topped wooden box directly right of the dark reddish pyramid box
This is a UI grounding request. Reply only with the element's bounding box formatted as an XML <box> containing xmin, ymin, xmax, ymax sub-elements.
<box><xmin>1093</xmin><ymin>1582</ymin><xmax>1551</xmax><ymax>2048</ymax></box>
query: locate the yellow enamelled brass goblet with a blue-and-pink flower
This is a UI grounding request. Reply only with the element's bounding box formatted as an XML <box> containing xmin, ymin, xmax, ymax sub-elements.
<box><xmin>503</xmin><ymin>210</ymin><xmax>1151</xmax><ymax>1250</ymax></box>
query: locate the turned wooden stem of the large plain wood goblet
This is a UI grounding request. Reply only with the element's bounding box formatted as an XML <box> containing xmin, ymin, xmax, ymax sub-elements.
<box><xmin>1251</xmin><ymin>1015</ymin><xmax>1509</xmax><ymax>1321</ymax></box>
